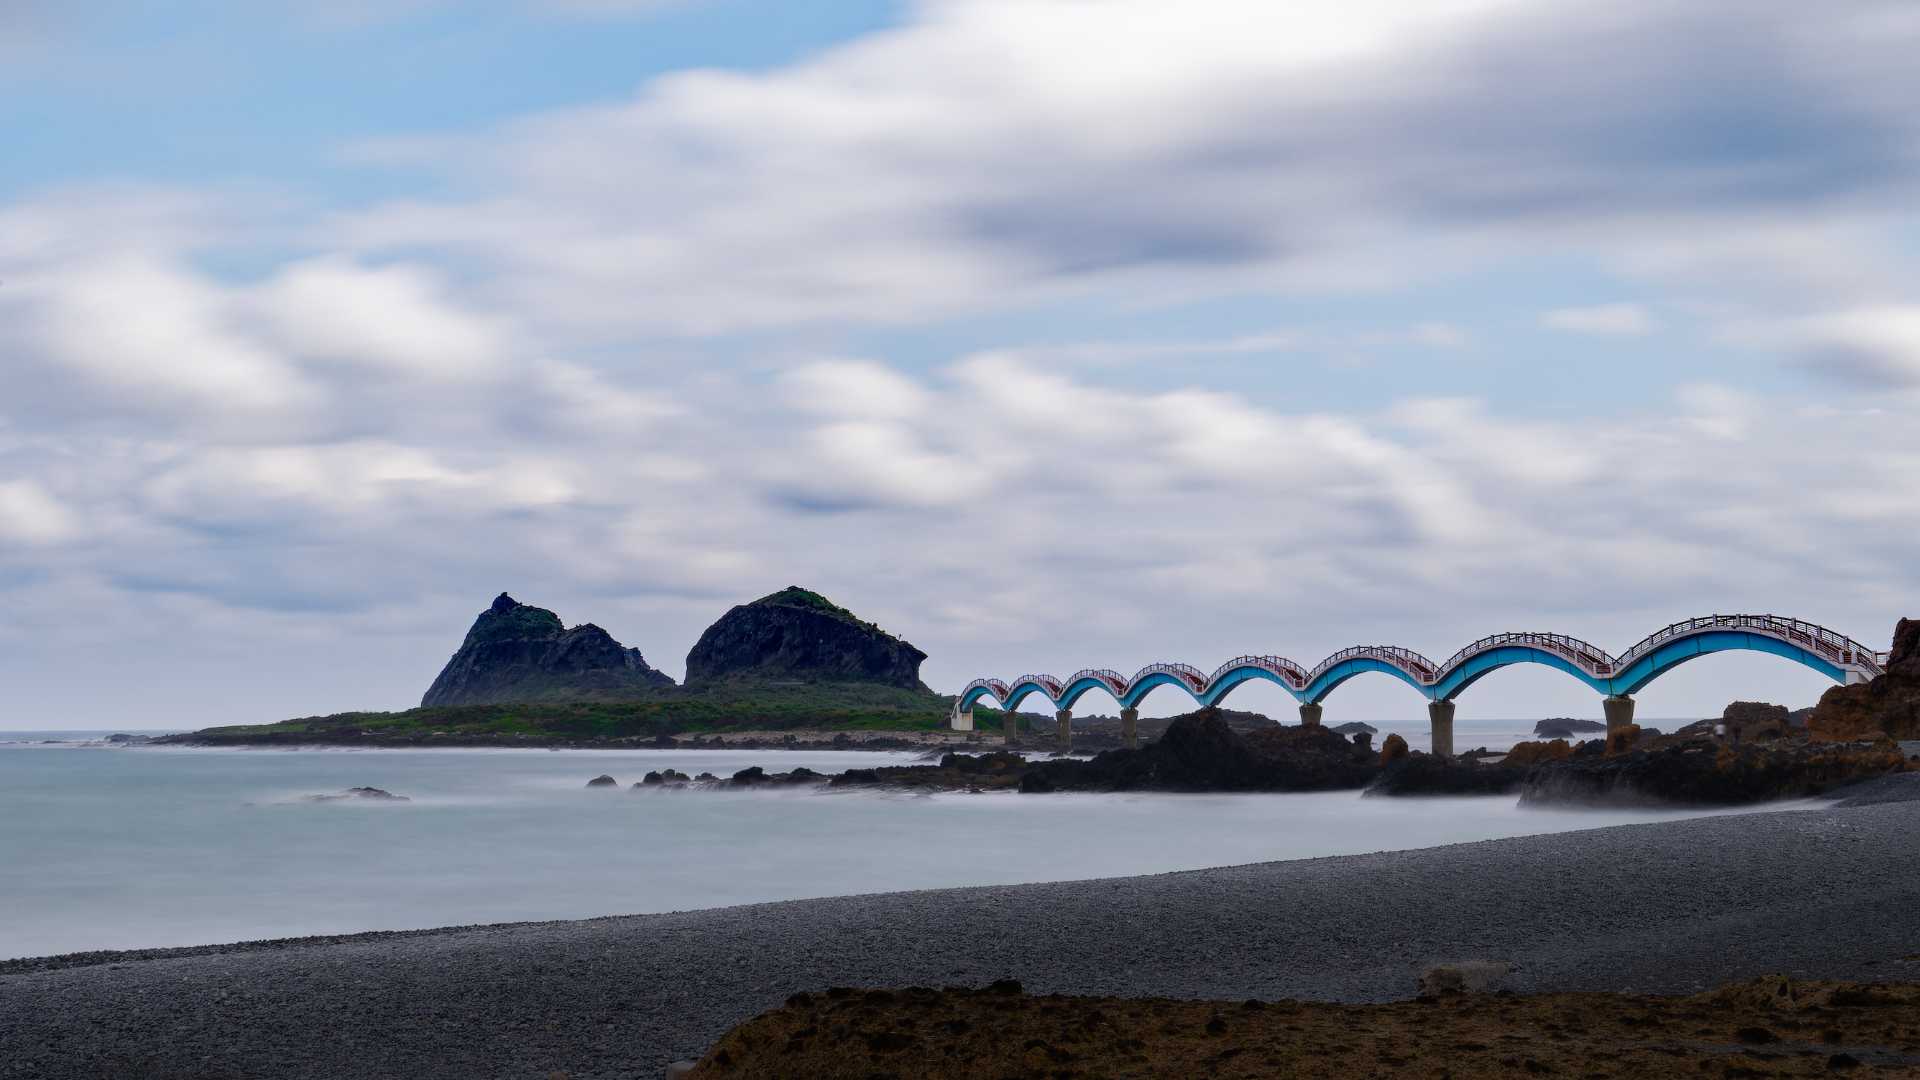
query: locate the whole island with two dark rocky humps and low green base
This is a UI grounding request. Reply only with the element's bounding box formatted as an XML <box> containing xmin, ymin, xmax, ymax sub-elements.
<box><xmin>163</xmin><ymin>586</ymin><xmax>975</xmax><ymax>748</ymax></box>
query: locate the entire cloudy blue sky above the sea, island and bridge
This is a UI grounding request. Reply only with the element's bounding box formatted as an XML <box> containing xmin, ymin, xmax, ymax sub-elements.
<box><xmin>0</xmin><ymin>0</ymin><xmax>1920</xmax><ymax>728</ymax></box>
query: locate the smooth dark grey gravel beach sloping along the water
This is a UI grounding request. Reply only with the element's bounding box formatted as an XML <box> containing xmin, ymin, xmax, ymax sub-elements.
<box><xmin>0</xmin><ymin>799</ymin><xmax>1920</xmax><ymax>1080</ymax></box>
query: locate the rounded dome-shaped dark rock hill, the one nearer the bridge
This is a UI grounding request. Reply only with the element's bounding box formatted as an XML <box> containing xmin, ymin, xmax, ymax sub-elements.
<box><xmin>687</xmin><ymin>586</ymin><xmax>927</xmax><ymax>690</ymax></box>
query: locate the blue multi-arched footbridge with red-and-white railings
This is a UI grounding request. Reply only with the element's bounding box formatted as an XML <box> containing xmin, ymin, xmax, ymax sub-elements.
<box><xmin>950</xmin><ymin>615</ymin><xmax>1887</xmax><ymax>755</ymax></box>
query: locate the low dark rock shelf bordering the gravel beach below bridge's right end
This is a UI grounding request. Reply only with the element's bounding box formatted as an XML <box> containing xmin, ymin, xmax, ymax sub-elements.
<box><xmin>1521</xmin><ymin>742</ymin><xmax>1907</xmax><ymax>805</ymax></box>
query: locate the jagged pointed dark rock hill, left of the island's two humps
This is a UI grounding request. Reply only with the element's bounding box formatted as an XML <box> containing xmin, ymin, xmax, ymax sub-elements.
<box><xmin>420</xmin><ymin>592</ymin><xmax>674</xmax><ymax>707</ymax></box>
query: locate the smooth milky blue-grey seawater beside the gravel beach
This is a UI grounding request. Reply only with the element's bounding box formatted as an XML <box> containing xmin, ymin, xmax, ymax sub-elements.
<box><xmin>0</xmin><ymin>732</ymin><xmax>1781</xmax><ymax>957</ymax></box>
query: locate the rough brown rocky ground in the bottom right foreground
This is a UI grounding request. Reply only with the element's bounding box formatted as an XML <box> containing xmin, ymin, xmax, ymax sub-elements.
<box><xmin>687</xmin><ymin>965</ymin><xmax>1920</xmax><ymax>1080</ymax></box>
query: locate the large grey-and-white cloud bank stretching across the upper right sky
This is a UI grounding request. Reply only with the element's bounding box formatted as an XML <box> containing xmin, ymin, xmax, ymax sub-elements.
<box><xmin>344</xmin><ymin>0</ymin><xmax>1920</xmax><ymax>334</ymax></box>
